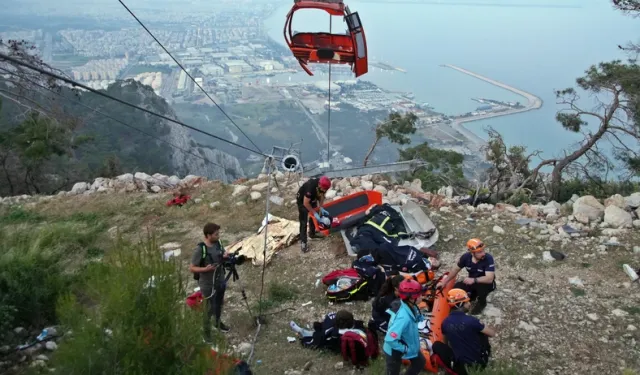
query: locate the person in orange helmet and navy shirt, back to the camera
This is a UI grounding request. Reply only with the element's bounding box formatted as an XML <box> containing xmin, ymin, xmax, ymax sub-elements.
<box><xmin>433</xmin><ymin>288</ymin><xmax>496</xmax><ymax>375</ymax></box>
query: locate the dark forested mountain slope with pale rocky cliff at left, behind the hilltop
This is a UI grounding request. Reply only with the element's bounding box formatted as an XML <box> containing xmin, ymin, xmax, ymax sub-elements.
<box><xmin>0</xmin><ymin>80</ymin><xmax>245</xmax><ymax>195</ymax></box>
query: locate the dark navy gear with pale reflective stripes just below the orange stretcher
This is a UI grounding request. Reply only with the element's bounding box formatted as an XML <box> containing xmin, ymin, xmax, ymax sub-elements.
<box><xmin>350</xmin><ymin>203</ymin><xmax>407</xmax><ymax>252</ymax></box>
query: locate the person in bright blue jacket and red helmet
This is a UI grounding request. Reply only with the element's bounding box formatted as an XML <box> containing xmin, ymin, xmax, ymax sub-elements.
<box><xmin>382</xmin><ymin>279</ymin><xmax>426</xmax><ymax>375</ymax></box>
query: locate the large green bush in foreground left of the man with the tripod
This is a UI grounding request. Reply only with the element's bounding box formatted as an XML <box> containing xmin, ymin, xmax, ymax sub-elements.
<box><xmin>54</xmin><ymin>239</ymin><xmax>224</xmax><ymax>375</ymax></box>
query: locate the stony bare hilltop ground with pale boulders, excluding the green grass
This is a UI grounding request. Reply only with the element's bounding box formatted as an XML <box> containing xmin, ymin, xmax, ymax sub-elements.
<box><xmin>0</xmin><ymin>173</ymin><xmax>640</xmax><ymax>375</ymax></box>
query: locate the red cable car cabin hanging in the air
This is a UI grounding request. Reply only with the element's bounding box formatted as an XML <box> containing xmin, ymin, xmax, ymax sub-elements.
<box><xmin>284</xmin><ymin>0</ymin><xmax>369</xmax><ymax>77</ymax></box>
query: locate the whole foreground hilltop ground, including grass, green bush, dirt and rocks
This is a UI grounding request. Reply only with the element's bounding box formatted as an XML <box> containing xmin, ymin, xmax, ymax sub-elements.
<box><xmin>0</xmin><ymin>173</ymin><xmax>640</xmax><ymax>374</ymax></box>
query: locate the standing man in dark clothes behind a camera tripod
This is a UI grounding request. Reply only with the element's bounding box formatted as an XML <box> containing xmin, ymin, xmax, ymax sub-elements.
<box><xmin>189</xmin><ymin>223</ymin><xmax>229</xmax><ymax>343</ymax></box>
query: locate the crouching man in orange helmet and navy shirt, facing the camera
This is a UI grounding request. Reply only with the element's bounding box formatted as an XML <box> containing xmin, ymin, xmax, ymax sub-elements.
<box><xmin>437</xmin><ymin>238</ymin><xmax>496</xmax><ymax>315</ymax></box>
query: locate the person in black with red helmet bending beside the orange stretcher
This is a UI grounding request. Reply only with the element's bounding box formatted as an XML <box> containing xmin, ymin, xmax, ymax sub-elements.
<box><xmin>296</xmin><ymin>176</ymin><xmax>331</xmax><ymax>253</ymax></box>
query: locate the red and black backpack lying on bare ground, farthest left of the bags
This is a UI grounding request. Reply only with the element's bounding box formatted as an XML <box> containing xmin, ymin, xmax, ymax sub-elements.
<box><xmin>322</xmin><ymin>268</ymin><xmax>369</xmax><ymax>302</ymax></box>
